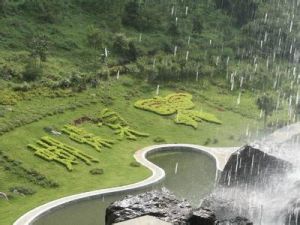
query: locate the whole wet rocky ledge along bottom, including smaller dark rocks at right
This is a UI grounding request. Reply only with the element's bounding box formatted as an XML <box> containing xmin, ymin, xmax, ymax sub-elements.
<box><xmin>105</xmin><ymin>189</ymin><xmax>252</xmax><ymax>225</ymax></box>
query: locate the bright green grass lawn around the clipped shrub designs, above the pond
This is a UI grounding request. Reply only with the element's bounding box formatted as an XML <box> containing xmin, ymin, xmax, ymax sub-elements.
<box><xmin>0</xmin><ymin>77</ymin><xmax>261</xmax><ymax>225</ymax></box>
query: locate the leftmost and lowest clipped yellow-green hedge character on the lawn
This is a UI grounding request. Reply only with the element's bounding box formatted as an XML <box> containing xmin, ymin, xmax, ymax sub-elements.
<box><xmin>28</xmin><ymin>136</ymin><xmax>99</xmax><ymax>171</ymax></box>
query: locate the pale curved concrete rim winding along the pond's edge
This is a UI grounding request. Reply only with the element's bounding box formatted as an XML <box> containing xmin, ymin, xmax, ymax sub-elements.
<box><xmin>13</xmin><ymin>144</ymin><xmax>238</xmax><ymax>225</ymax></box>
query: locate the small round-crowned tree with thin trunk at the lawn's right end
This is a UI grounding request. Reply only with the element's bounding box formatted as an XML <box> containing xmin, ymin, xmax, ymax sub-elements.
<box><xmin>256</xmin><ymin>93</ymin><xmax>276</xmax><ymax>128</ymax></box>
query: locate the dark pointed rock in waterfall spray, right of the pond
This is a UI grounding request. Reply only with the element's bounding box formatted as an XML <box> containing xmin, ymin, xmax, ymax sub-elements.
<box><xmin>219</xmin><ymin>145</ymin><xmax>292</xmax><ymax>187</ymax></box>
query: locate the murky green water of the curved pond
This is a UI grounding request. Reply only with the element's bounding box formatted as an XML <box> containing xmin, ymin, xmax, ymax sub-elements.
<box><xmin>33</xmin><ymin>149</ymin><xmax>216</xmax><ymax>225</ymax></box>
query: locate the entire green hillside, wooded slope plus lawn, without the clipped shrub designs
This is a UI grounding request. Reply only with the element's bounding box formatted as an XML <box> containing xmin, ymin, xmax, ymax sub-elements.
<box><xmin>0</xmin><ymin>0</ymin><xmax>300</xmax><ymax>225</ymax></box>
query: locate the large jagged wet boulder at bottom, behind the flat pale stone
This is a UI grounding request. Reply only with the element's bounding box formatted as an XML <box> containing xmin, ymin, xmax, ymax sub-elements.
<box><xmin>105</xmin><ymin>190</ymin><xmax>192</xmax><ymax>225</ymax></box>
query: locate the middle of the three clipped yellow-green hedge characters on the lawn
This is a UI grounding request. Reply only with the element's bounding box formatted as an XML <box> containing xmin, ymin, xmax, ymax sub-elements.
<box><xmin>62</xmin><ymin>125</ymin><xmax>114</xmax><ymax>152</ymax></box>
